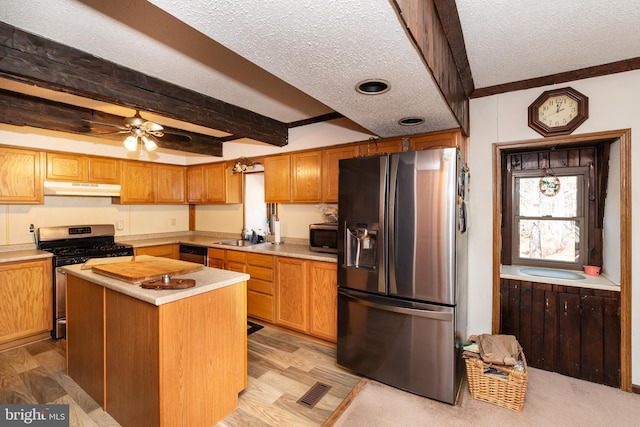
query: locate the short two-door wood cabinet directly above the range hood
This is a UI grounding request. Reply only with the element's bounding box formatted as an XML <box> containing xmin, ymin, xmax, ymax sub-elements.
<box><xmin>46</xmin><ymin>152</ymin><xmax>121</xmax><ymax>184</ymax></box>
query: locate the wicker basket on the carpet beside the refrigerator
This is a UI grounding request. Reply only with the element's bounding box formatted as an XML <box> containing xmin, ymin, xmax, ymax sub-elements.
<box><xmin>465</xmin><ymin>352</ymin><xmax>528</xmax><ymax>412</ymax></box>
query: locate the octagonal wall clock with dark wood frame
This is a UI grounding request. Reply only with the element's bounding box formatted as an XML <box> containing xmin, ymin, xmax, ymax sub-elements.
<box><xmin>529</xmin><ymin>87</ymin><xmax>589</xmax><ymax>136</ymax></box>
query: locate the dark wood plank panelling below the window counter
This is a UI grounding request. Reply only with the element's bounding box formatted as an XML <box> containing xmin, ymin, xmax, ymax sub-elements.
<box><xmin>500</xmin><ymin>279</ymin><xmax>620</xmax><ymax>387</ymax></box>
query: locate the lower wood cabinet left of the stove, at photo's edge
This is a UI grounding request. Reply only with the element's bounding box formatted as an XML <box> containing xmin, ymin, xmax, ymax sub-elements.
<box><xmin>0</xmin><ymin>258</ymin><xmax>53</xmax><ymax>350</ymax></box>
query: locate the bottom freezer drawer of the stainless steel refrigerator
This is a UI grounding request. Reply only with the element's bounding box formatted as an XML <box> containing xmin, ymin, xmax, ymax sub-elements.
<box><xmin>337</xmin><ymin>289</ymin><xmax>462</xmax><ymax>404</ymax></box>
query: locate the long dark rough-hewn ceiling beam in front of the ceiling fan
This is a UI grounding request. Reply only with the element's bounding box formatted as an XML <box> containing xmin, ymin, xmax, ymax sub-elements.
<box><xmin>0</xmin><ymin>22</ymin><xmax>288</xmax><ymax>147</ymax></box>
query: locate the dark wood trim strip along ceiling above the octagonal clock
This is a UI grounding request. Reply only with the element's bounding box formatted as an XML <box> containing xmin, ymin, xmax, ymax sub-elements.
<box><xmin>471</xmin><ymin>58</ymin><xmax>640</xmax><ymax>98</ymax></box>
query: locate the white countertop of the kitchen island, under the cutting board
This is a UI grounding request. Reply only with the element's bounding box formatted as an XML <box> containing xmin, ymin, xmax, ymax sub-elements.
<box><xmin>62</xmin><ymin>256</ymin><xmax>249</xmax><ymax>306</ymax></box>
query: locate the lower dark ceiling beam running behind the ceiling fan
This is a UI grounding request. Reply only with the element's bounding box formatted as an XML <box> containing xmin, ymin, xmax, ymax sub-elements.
<box><xmin>0</xmin><ymin>89</ymin><xmax>222</xmax><ymax>157</ymax></box>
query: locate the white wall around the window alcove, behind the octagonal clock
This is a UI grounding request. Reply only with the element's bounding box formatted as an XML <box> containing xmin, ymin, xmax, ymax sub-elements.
<box><xmin>468</xmin><ymin>71</ymin><xmax>640</xmax><ymax>384</ymax></box>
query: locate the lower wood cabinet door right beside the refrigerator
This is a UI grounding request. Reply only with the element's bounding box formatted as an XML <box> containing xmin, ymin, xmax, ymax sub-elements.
<box><xmin>308</xmin><ymin>262</ymin><xmax>338</xmax><ymax>342</ymax></box>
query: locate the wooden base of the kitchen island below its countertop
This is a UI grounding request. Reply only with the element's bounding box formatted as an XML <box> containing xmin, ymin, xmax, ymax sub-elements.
<box><xmin>67</xmin><ymin>277</ymin><xmax>247</xmax><ymax>427</ymax></box>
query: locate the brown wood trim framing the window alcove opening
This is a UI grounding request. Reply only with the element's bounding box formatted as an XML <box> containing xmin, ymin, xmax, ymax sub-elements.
<box><xmin>491</xmin><ymin>129</ymin><xmax>639</xmax><ymax>391</ymax></box>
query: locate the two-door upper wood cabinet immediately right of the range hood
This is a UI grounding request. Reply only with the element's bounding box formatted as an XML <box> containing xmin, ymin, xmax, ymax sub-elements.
<box><xmin>119</xmin><ymin>161</ymin><xmax>186</xmax><ymax>204</ymax></box>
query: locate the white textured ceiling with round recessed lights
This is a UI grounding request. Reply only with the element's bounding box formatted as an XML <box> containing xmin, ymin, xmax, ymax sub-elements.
<box><xmin>0</xmin><ymin>0</ymin><xmax>640</xmax><ymax>153</ymax></box>
